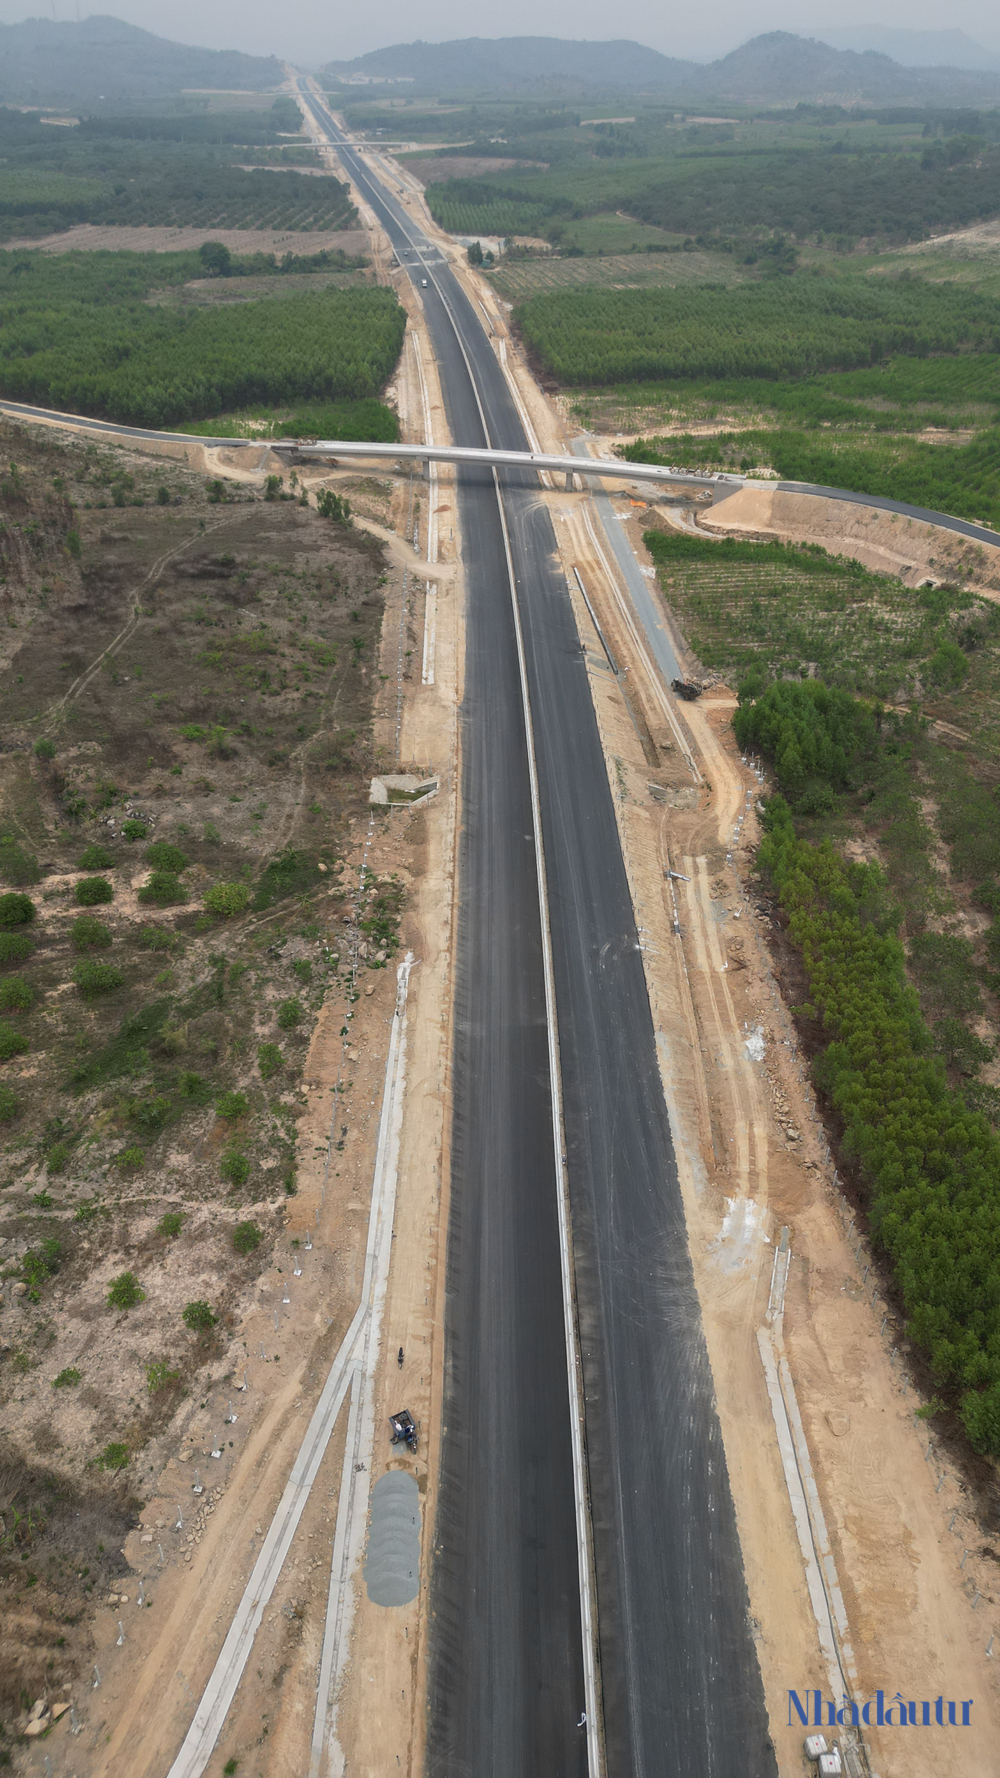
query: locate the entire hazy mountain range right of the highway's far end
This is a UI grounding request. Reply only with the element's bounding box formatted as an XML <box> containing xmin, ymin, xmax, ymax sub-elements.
<box><xmin>322</xmin><ymin>30</ymin><xmax>1000</xmax><ymax>105</ymax></box>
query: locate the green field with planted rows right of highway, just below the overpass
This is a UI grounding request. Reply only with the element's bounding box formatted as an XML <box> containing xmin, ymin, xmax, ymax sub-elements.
<box><xmin>660</xmin><ymin>546</ymin><xmax>929</xmax><ymax>697</ymax></box>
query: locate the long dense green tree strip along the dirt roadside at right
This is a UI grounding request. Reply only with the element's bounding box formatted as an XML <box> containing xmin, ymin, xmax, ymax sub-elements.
<box><xmin>760</xmin><ymin>797</ymin><xmax>1000</xmax><ymax>1456</ymax></box>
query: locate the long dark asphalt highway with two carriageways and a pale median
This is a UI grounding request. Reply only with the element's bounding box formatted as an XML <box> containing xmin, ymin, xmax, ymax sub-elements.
<box><xmin>306</xmin><ymin>94</ymin><xmax>776</xmax><ymax>1778</ymax></box>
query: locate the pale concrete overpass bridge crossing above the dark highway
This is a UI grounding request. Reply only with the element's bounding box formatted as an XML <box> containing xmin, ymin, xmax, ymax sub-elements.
<box><xmin>270</xmin><ymin>439</ymin><xmax>746</xmax><ymax>505</ymax></box>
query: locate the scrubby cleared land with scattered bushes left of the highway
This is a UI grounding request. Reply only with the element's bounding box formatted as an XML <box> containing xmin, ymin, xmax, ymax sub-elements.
<box><xmin>0</xmin><ymin>412</ymin><xmax>400</xmax><ymax>1714</ymax></box>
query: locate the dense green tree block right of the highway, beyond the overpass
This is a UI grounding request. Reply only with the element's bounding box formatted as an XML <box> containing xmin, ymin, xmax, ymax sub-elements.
<box><xmin>516</xmin><ymin>276</ymin><xmax>1000</xmax><ymax>384</ymax></box>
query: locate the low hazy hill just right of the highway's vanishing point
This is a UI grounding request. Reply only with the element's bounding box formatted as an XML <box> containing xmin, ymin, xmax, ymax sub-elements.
<box><xmin>322</xmin><ymin>37</ymin><xmax>701</xmax><ymax>94</ymax></box>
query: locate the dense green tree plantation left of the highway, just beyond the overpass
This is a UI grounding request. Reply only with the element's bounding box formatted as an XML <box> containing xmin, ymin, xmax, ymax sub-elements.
<box><xmin>0</xmin><ymin>252</ymin><xmax>406</xmax><ymax>427</ymax></box>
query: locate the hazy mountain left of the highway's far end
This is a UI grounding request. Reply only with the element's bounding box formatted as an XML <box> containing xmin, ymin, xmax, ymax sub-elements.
<box><xmin>0</xmin><ymin>16</ymin><xmax>285</xmax><ymax>110</ymax></box>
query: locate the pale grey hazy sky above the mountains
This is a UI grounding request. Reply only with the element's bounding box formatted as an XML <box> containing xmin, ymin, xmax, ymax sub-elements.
<box><xmin>0</xmin><ymin>0</ymin><xmax>1000</xmax><ymax>68</ymax></box>
